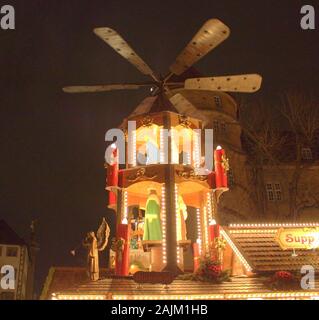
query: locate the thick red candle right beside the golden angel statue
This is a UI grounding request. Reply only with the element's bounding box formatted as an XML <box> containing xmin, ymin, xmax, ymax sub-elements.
<box><xmin>115</xmin><ymin>223</ymin><xmax>130</xmax><ymax>276</ymax></box>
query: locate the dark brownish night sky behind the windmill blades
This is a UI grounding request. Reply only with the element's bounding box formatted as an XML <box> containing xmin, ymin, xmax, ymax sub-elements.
<box><xmin>0</xmin><ymin>0</ymin><xmax>319</xmax><ymax>292</ymax></box>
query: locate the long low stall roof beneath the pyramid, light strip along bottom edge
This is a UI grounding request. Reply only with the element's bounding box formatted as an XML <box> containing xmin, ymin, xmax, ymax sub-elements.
<box><xmin>41</xmin><ymin>268</ymin><xmax>319</xmax><ymax>300</ymax></box>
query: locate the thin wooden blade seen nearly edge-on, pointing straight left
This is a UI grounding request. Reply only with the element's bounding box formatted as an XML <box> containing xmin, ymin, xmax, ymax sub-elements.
<box><xmin>63</xmin><ymin>84</ymin><xmax>152</xmax><ymax>93</ymax></box>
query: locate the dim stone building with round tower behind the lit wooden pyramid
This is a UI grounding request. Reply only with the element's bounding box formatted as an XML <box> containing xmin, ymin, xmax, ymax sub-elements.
<box><xmin>172</xmin><ymin>90</ymin><xmax>319</xmax><ymax>225</ymax></box>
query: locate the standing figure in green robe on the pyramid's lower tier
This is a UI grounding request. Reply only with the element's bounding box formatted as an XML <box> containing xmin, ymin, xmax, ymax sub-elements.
<box><xmin>143</xmin><ymin>189</ymin><xmax>162</xmax><ymax>240</ymax></box>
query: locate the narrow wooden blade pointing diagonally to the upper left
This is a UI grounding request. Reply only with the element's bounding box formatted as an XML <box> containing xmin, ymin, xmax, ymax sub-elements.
<box><xmin>94</xmin><ymin>28</ymin><xmax>158</xmax><ymax>81</ymax></box>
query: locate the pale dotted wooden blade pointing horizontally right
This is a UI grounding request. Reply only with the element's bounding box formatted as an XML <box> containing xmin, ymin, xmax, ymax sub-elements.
<box><xmin>185</xmin><ymin>74</ymin><xmax>262</xmax><ymax>92</ymax></box>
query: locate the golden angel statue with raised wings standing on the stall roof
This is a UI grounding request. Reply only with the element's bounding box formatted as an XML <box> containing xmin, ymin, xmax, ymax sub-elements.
<box><xmin>83</xmin><ymin>218</ymin><xmax>110</xmax><ymax>281</ymax></box>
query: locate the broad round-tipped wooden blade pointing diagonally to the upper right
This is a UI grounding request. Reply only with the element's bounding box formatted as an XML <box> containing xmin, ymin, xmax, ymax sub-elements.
<box><xmin>169</xmin><ymin>19</ymin><xmax>230</xmax><ymax>75</ymax></box>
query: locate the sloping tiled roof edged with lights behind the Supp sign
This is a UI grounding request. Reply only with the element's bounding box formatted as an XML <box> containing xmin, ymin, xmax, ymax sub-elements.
<box><xmin>223</xmin><ymin>224</ymin><xmax>319</xmax><ymax>273</ymax></box>
